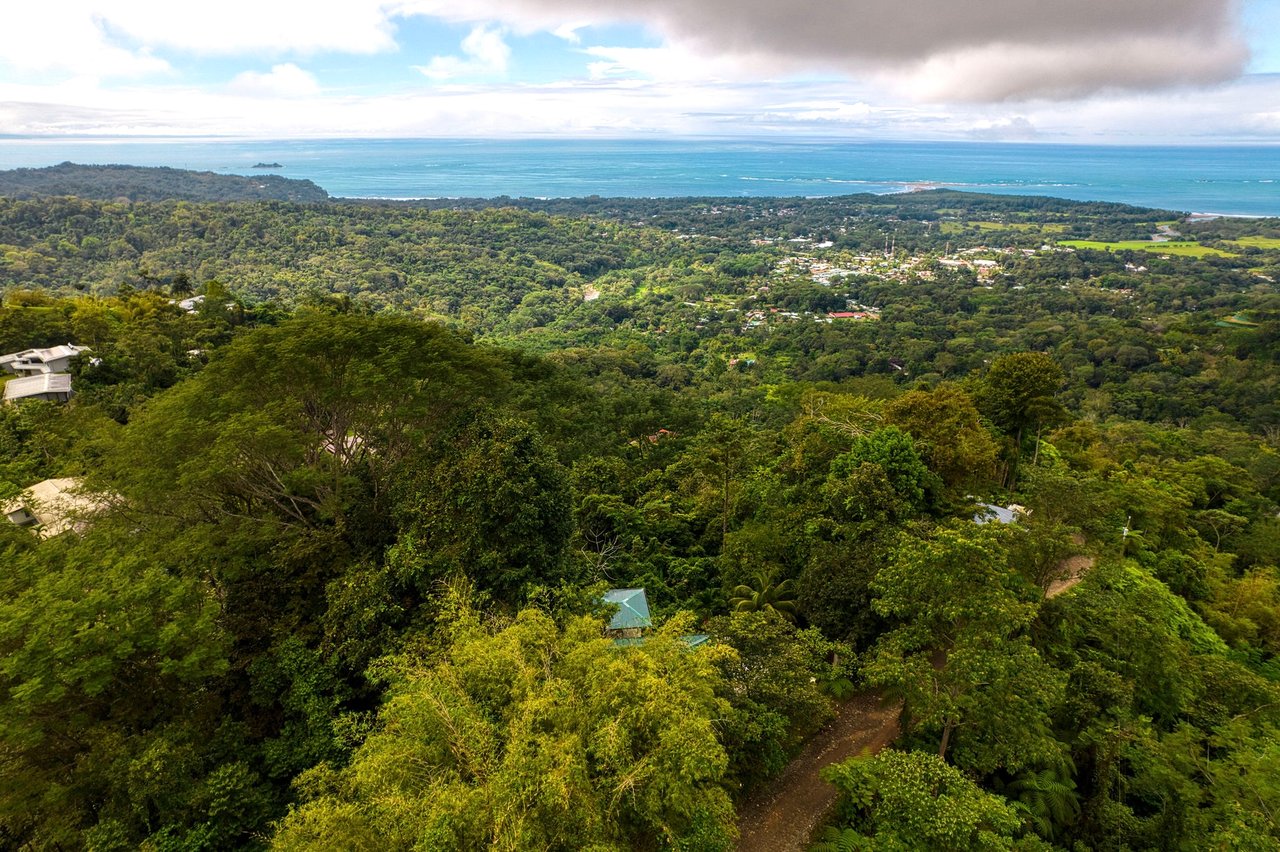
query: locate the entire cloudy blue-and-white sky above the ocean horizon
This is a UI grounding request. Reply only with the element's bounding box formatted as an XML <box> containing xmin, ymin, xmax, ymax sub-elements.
<box><xmin>0</xmin><ymin>0</ymin><xmax>1280</xmax><ymax>145</ymax></box>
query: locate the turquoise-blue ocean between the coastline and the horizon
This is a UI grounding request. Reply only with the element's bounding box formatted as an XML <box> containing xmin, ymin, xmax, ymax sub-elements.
<box><xmin>0</xmin><ymin>138</ymin><xmax>1280</xmax><ymax>216</ymax></box>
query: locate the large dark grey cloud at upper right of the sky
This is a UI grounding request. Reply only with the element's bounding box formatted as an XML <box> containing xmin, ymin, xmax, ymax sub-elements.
<box><xmin>458</xmin><ymin>0</ymin><xmax>1248</xmax><ymax>100</ymax></box>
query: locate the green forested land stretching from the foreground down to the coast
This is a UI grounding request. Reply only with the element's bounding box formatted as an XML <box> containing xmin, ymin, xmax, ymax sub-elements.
<box><xmin>0</xmin><ymin>192</ymin><xmax>1280</xmax><ymax>851</ymax></box>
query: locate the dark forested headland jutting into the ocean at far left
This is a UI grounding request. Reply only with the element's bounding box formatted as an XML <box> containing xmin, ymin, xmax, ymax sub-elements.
<box><xmin>0</xmin><ymin>162</ymin><xmax>329</xmax><ymax>203</ymax></box>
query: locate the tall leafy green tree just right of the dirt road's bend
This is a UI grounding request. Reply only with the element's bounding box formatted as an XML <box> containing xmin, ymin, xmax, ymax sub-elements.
<box><xmin>867</xmin><ymin>522</ymin><xmax>1062</xmax><ymax>773</ymax></box>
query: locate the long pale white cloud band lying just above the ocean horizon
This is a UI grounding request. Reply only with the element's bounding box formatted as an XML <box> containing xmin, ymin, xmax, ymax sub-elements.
<box><xmin>0</xmin><ymin>75</ymin><xmax>1280</xmax><ymax>143</ymax></box>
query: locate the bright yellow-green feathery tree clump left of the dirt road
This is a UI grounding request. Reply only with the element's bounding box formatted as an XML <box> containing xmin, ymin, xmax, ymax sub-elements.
<box><xmin>273</xmin><ymin>610</ymin><xmax>733</xmax><ymax>852</ymax></box>
